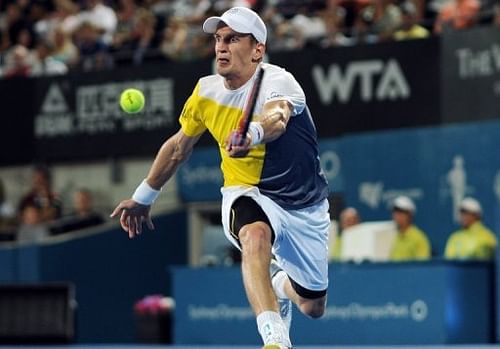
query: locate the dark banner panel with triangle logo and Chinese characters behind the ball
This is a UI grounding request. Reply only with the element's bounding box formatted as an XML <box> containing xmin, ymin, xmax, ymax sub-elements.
<box><xmin>33</xmin><ymin>62</ymin><xmax>210</xmax><ymax>161</ymax></box>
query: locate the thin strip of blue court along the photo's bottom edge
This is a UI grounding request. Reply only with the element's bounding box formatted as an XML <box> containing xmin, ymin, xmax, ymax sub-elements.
<box><xmin>0</xmin><ymin>344</ymin><xmax>500</xmax><ymax>349</ymax></box>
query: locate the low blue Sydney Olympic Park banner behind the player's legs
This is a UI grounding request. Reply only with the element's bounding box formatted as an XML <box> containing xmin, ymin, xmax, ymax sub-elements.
<box><xmin>173</xmin><ymin>261</ymin><xmax>493</xmax><ymax>345</ymax></box>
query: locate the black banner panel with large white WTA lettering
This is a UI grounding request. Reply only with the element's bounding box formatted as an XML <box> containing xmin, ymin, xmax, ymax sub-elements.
<box><xmin>270</xmin><ymin>38</ymin><xmax>440</xmax><ymax>137</ymax></box>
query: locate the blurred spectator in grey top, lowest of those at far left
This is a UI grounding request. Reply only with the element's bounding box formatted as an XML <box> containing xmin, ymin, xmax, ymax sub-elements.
<box><xmin>17</xmin><ymin>202</ymin><xmax>49</xmax><ymax>242</ymax></box>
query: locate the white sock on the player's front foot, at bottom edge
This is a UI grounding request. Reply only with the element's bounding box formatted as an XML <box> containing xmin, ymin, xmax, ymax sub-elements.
<box><xmin>257</xmin><ymin>311</ymin><xmax>292</xmax><ymax>348</ymax></box>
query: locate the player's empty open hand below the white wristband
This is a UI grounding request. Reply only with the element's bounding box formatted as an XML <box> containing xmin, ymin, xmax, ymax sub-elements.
<box><xmin>110</xmin><ymin>199</ymin><xmax>155</xmax><ymax>239</ymax></box>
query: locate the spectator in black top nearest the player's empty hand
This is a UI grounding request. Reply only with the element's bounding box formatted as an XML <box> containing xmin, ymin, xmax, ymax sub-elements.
<box><xmin>50</xmin><ymin>189</ymin><xmax>105</xmax><ymax>235</ymax></box>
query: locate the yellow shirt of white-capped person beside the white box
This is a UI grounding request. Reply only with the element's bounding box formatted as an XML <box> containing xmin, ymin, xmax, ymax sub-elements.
<box><xmin>389</xmin><ymin>225</ymin><xmax>431</xmax><ymax>262</ymax></box>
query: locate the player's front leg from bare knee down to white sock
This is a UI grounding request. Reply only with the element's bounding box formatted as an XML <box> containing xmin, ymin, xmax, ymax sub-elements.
<box><xmin>239</xmin><ymin>222</ymin><xmax>291</xmax><ymax>349</ymax></box>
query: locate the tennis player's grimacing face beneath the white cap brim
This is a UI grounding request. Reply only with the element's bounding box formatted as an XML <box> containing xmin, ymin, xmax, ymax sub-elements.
<box><xmin>214</xmin><ymin>26</ymin><xmax>262</xmax><ymax>83</ymax></box>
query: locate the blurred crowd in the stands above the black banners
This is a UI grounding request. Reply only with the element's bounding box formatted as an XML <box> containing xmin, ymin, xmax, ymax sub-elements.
<box><xmin>0</xmin><ymin>0</ymin><xmax>500</xmax><ymax>78</ymax></box>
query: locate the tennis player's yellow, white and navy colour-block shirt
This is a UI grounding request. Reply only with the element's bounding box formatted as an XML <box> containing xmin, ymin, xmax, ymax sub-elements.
<box><xmin>179</xmin><ymin>63</ymin><xmax>328</xmax><ymax>209</ymax></box>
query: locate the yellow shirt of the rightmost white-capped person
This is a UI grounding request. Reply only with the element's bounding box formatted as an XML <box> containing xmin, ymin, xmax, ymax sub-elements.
<box><xmin>444</xmin><ymin>222</ymin><xmax>497</xmax><ymax>260</ymax></box>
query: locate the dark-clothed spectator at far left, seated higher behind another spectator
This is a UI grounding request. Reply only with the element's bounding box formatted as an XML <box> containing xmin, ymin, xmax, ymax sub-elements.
<box><xmin>18</xmin><ymin>166</ymin><xmax>62</xmax><ymax>222</ymax></box>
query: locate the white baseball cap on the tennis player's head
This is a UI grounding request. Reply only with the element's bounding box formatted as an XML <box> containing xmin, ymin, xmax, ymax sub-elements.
<box><xmin>203</xmin><ymin>7</ymin><xmax>267</xmax><ymax>44</ymax></box>
